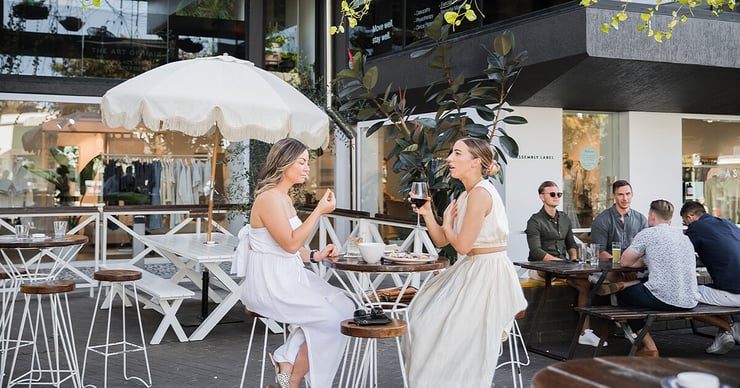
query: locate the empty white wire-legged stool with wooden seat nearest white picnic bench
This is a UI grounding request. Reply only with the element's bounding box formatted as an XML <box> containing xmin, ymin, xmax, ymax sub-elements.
<box><xmin>82</xmin><ymin>269</ymin><xmax>152</xmax><ymax>387</ymax></box>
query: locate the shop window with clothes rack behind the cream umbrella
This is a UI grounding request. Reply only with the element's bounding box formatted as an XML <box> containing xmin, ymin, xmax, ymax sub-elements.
<box><xmin>0</xmin><ymin>100</ymin><xmax>225</xmax><ymax>207</ymax></box>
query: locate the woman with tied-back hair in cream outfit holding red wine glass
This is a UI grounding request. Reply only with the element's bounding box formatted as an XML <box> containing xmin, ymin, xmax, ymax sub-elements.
<box><xmin>405</xmin><ymin>138</ymin><xmax>527</xmax><ymax>388</ymax></box>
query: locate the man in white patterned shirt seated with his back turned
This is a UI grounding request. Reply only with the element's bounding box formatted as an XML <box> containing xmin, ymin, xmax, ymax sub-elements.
<box><xmin>599</xmin><ymin>199</ymin><xmax>699</xmax><ymax>357</ymax></box>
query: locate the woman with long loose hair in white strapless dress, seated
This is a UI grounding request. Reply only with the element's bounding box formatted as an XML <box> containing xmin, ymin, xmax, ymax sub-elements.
<box><xmin>232</xmin><ymin>139</ymin><xmax>354</xmax><ymax>388</ymax></box>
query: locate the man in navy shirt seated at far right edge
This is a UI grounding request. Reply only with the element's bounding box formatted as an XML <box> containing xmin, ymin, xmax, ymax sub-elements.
<box><xmin>681</xmin><ymin>201</ymin><xmax>740</xmax><ymax>354</ymax></box>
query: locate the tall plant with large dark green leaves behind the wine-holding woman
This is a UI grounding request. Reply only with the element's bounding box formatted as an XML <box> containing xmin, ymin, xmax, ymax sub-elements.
<box><xmin>336</xmin><ymin>15</ymin><xmax>527</xmax><ymax>224</ymax></box>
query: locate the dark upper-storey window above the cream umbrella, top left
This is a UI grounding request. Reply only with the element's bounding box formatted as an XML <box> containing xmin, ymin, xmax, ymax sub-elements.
<box><xmin>0</xmin><ymin>0</ymin><xmax>246</xmax><ymax>79</ymax></box>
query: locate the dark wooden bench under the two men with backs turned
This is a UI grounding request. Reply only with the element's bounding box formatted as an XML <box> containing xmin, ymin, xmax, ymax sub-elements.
<box><xmin>568</xmin><ymin>303</ymin><xmax>740</xmax><ymax>359</ymax></box>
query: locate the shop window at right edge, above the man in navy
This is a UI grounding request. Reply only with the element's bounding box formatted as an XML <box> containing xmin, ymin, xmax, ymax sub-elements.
<box><xmin>682</xmin><ymin>119</ymin><xmax>740</xmax><ymax>224</ymax></box>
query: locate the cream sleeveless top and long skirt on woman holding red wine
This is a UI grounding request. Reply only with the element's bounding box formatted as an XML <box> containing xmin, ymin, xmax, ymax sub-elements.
<box><xmin>405</xmin><ymin>180</ymin><xmax>527</xmax><ymax>388</ymax></box>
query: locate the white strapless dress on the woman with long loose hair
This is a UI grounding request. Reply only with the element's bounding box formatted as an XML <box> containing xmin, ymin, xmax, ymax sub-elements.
<box><xmin>232</xmin><ymin>216</ymin><xmax>354</xmax><ymax>388</ymax></box>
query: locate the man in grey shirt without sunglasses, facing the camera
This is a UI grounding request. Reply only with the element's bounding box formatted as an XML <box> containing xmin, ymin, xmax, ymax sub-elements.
<box><xmin>591</xmin><ymin>180</ymin><xmax>648</xmax><ymax>259</ymax></box>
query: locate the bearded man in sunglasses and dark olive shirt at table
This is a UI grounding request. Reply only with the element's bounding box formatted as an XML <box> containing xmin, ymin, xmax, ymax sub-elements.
<box><xmin>526</xmin><ymin>181</ymin><xmax>607</xmax><ymax>346</ymax></box>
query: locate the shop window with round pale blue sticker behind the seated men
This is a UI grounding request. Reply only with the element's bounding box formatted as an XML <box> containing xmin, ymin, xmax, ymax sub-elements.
<box><xmin>562</xmin><ymin>112</ymin><xmax>619</xmax><ymax>228</ymax></box>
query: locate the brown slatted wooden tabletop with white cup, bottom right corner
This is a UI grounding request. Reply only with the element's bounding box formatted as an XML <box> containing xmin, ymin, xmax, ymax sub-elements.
<box><xmin>532</xmin><ymin>357</ymin><xmax>740</xmax><ymax>388</ymax></box>
